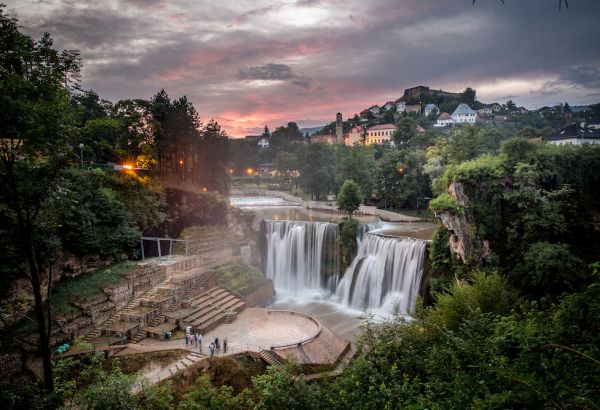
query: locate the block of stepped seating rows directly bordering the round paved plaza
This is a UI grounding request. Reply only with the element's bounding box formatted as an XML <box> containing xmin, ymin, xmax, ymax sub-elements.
<box><xmin>180</xmin><ymin>287</ymin><xmax>246</xmax><ymax>333</ymax></box>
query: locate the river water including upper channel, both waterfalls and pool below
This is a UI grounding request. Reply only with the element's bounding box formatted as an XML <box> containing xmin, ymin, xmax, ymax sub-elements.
<box><xmin>231</xmin><ymin>198</ymin><xmax>436</xmax><ymax>340</ymax></box>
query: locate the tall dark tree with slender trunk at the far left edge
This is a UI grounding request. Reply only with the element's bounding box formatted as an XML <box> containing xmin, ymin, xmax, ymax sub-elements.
<box><xmin>0</xmin><ymin>6</ymin><xmax>80</xmax><ymax>390</ymax></box>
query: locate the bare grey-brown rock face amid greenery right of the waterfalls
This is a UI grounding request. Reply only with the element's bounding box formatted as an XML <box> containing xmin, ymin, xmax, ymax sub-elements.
<box><xmin>435</xmin><ymin>182</ymin><xmax>490</xmax><ymax>263</ymax></box>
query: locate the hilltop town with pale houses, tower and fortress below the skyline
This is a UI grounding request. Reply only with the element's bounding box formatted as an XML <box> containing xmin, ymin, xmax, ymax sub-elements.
<box><xmin>246</xmin><ymin>85</ymin><xmax>600</xmax><ymax>148</ymax></box>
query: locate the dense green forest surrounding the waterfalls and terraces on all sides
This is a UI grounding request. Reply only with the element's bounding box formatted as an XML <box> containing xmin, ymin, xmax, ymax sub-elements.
<box><xmin>0</xmin><ymin>8</ymin><xmax>600</xmax><ymax>409</ymax></box>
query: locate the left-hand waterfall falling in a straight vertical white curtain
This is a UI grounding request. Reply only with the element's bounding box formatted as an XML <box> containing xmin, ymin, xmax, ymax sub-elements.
<box><xmin>265</xmin><ymin>220</ymin><xmax>339</xmax><ymax>295</ymax></box>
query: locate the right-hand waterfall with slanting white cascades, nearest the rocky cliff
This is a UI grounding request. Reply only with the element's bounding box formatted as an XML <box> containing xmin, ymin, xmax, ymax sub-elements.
<box><xmin>336</xmin><ymin>234</ymin><xmax>426</xmax><ymax>314</ymax></box>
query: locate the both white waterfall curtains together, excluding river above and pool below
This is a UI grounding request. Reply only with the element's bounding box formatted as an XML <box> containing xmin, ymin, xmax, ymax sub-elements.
<box><xmin>265</xmin><ymin>221</ymin><xmax>426</xmax><ymax>315</ymax></box>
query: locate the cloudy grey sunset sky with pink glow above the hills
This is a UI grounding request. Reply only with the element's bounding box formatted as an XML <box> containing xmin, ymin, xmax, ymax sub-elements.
<box><xmin>7</xmin><ymin>0</ymin><xmax>600</xmax><ymax>137</ymax></box>
